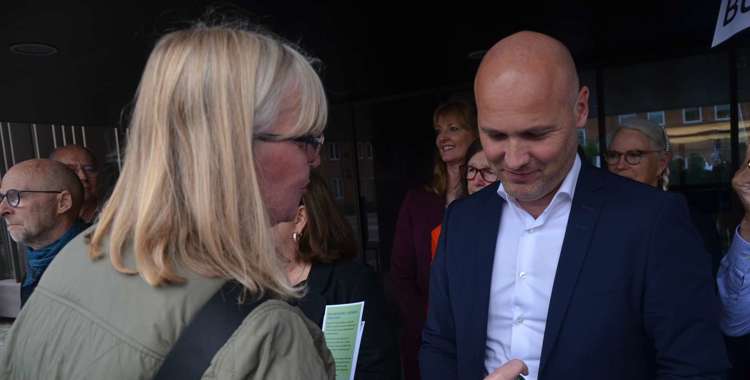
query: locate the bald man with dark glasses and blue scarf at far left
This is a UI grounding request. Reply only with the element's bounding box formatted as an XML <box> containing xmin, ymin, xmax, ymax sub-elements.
<box><xmin>0</xmin><ymin>160</ymin><xmax>87</xmax><ymax>305</ymax></box>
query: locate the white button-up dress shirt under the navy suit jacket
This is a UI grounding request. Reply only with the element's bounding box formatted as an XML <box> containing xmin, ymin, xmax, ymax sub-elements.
<box><xmin>484</xmin><ymin>156</ymin><xmax>581</xmax><ymax>380</ymax></box>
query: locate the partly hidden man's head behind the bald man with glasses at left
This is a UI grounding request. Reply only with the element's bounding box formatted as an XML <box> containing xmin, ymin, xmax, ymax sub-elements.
<box><xmin>49</xmin><ymin>144</ymin><xmax>99</xmax><ymax>223</ymax></box>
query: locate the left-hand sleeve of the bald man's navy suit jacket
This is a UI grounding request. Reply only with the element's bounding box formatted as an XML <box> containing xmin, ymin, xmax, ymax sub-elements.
<box><xmin>419</xmin><ymin>207</ymin><xmax>458</xmax><ymax>379</ymax></box>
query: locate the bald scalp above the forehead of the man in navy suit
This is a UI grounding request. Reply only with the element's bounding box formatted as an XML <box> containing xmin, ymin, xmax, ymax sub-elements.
<box><xmin>474</xmin><ymin>31</ymin><xmax>579</xmax><ymax>111</ymax></box>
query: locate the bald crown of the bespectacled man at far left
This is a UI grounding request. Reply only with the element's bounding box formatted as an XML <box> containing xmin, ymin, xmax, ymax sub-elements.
<box><xmin>2</xmin><ymin>159</ymin><xmax>83</xmax><ymax>216</ymax></box>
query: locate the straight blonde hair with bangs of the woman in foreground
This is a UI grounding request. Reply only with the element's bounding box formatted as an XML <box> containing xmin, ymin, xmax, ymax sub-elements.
<box><xmin>89</xmin><ymin>24</ymin><xmax>327</xmax><ymax>298</ymax></box>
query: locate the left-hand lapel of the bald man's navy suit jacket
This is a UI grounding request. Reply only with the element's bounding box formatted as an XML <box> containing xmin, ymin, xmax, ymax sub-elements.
<box><xmin>467</xmin><ymin>184</ymin><xmax>505</xmax><ymax>378</ymax></box>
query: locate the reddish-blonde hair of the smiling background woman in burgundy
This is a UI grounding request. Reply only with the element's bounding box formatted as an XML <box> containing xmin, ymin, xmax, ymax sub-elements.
<box><xmin>425</xmin><ymin>100</ymin><xmax>478</xmax><ymax>196</ymax></box>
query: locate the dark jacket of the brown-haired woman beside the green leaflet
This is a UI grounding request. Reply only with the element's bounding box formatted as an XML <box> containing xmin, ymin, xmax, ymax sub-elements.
<box><xmin>298</xmin><ymin>260</ymin><xmax>400</xmax><ymax>380</ymax></box>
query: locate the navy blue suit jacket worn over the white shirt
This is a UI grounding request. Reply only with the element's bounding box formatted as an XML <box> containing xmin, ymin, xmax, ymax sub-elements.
<box><xmin>420</xmin><ymin>163</ymin><xmax>729</xmax><ymax>380</ymax></box>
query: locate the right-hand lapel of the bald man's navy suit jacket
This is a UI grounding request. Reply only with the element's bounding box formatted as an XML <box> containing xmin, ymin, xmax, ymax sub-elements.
<box><xmin>539</xmin><ymin>162</ymin><xmax>604</xmax><ymax>378</ymax></box>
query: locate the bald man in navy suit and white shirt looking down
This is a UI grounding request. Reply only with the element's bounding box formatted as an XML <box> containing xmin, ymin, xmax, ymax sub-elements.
<box><xmin>420</xmin><ymin>32</ymin><xmax>728</xmax><ymax>380</ymax></box>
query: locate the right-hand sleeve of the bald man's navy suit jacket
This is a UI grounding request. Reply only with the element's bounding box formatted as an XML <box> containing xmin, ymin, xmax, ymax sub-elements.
<box><xmin>643</xmin><ymin>195</ymin><xmax>729</xmax><ymax>380</ymax></box>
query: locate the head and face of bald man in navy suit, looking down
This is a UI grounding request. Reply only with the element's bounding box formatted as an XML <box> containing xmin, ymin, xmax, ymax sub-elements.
<box><xmin>474</xmin><ymin>32</ymin><xmax>588</xmax><ymax>217</ymax></box>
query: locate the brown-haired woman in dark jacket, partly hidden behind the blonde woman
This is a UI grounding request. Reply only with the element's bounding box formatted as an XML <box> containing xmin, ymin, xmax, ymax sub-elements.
<box><xmin>274</xmin><ymin>172</ymin><xmax>400</xmax><ymax>380</ymax></box>
